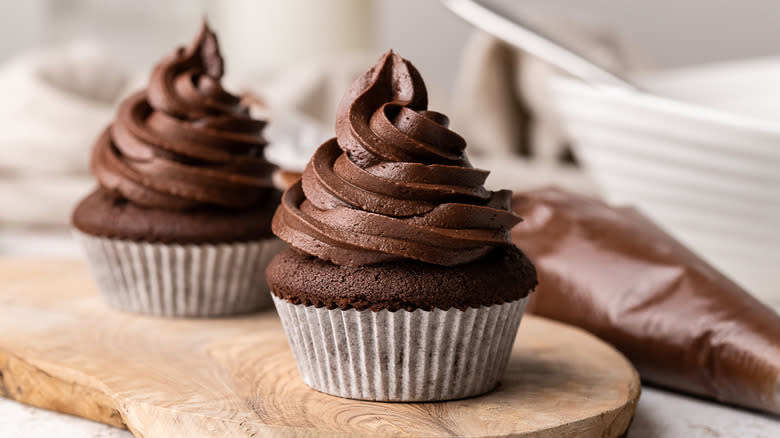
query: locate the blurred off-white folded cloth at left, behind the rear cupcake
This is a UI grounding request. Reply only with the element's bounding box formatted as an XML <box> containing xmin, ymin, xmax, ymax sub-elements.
<box><xmin>0</xmin><ymin>43</ymin><xmax>128</xmax><ymax>229</ymax></box>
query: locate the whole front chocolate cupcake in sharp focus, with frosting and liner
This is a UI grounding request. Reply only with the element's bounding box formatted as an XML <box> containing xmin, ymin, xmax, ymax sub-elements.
<box><xmin>266</xmin><ymin>52</ymin><xmax>536</xmax><ymax>401</ymax></box>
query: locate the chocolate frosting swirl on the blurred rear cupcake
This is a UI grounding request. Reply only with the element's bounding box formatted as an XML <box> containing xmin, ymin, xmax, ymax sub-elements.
<box><xmin>91</xmin><ymin>22</ymin><xmax>274</xmax><ymax>210</ymax></box>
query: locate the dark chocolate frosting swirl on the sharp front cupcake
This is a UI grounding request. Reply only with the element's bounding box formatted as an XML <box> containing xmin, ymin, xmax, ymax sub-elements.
<box><xmin>273</xmin><ymin>51</ymin><xmax>520</xmax><ymax>266</ymax></box>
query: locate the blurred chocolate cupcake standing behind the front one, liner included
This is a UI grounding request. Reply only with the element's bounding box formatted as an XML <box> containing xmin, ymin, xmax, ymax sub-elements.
<box><xmin>72</xmin><ymin>22</ymin><xmax>284</xmax><ymax>317</ymax></box>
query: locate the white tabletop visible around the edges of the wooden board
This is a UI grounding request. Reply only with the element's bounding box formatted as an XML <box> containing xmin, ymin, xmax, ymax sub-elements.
<box><xmin>0</xmin><ymin>231</ymin><xmax>780</xmax><ymax>438</ymax></box>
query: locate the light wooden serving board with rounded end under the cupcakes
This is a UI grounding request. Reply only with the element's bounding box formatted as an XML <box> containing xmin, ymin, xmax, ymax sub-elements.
<box><xmin>0</xmin><ymin>259</ymin><xmax>640</xmax><ymax>438</ymax></box>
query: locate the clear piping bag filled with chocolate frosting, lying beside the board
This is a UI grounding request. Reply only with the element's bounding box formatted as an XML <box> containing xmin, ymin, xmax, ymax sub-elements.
<box><xmin>512</xmin><ymin>189</ymin><xmax>780</xmax><ymax>415</ymax></box>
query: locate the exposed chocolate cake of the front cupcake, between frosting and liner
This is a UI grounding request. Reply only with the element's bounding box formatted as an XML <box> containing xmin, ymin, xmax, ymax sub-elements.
<box><xmin>266</xmin><ymin>246</ymin><xmax>537</xmax><ymax>311</ymax></box>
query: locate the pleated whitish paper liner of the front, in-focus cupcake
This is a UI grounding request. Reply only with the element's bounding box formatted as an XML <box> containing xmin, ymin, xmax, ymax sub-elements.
<box><xmin>273</xmin><ymin>295</ymin><xmax>528</xmax><ymax>402</ymax></box>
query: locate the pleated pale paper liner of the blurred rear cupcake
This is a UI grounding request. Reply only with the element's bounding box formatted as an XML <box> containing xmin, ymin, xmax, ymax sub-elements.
<box><xmin>74</xmin><ymin>231</ymin><xmax>285</xmax><ymax>317</ymax></box>
